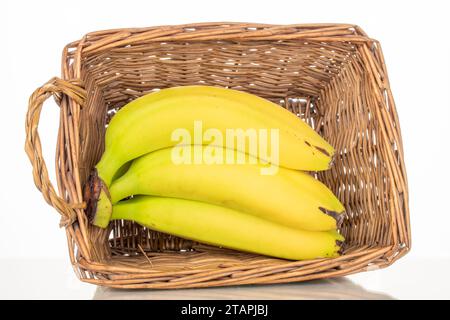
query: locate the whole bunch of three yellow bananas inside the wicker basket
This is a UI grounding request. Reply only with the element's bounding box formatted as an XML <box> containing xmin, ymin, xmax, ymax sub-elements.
<box><xmin>85</xmin><ymin>86</ymin><xmax>344</xmax><ymax>260</ymax></box>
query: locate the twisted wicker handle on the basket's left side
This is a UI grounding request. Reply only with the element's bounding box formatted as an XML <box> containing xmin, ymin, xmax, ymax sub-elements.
<box><xmin>25</xmin><ymin>77</ymin><xmax>86</xmax><ymax>226</ymax></box>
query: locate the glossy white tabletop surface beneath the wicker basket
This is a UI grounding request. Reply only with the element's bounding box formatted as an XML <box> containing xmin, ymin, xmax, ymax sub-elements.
<box><xmin>0</xmin><ymin>258</ymin><xmax>450</xmax><ymax>300</ymax></box>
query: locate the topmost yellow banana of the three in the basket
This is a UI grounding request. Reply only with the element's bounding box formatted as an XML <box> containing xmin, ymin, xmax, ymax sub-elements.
<box><xmin>96</xmin><ymin>86</ymin><xmax>334</xmax><ymax>186</ymax></box>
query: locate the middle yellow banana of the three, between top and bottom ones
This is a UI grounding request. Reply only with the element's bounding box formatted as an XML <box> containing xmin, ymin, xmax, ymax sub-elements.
<box><xmin>105</xmin><ymin>146</ymin><xmax>344</xmax><ymax>231</ymax></box>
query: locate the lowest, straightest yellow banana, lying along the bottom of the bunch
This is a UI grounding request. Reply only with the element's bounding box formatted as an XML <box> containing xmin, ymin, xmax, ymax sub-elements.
<box><xmin>112</xmin><ymin>196</ymin><xmax>344</xmax><ymax>260</ymax></box>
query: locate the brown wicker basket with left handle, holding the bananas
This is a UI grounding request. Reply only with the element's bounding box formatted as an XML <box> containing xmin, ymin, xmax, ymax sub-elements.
<box><xmin>25</xmin><ymin>23</ymin><xmax>411</xmax><ymax>288</ymax></box>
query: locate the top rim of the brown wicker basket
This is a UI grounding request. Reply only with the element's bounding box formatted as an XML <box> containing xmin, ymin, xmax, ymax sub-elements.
<box><xmin>63</xmin><ymin>22</ymin><xmax>378</xmax><ymax>62</ymax></box>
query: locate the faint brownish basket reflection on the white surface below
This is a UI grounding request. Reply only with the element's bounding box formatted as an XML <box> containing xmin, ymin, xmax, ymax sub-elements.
<box><xmin>93</xmin><ymin>278</ymin><xmax>392</xmax><ymax>300</ymax></box>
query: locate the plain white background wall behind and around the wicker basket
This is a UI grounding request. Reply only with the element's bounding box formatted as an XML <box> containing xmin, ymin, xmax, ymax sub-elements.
<box><xmin>0</xmin><ymin>0</ymin><xmax>450</xmax><ymax>298</ymax></box>
